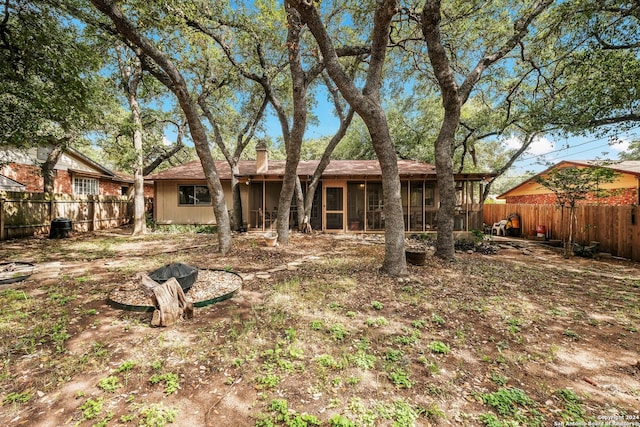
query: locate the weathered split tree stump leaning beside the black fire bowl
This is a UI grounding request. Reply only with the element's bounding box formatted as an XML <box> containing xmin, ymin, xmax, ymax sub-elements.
<box><xmin>141</xmin><ymin>274</ymin><xmax>193</xmax><ymax>326</ymax></box>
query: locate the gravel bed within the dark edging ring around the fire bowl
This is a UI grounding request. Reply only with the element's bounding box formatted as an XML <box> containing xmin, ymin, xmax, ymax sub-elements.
<box><xmin>109</xmin><ymin>269</ymin><xmax>242</xmax><ymax>311</ymax></box>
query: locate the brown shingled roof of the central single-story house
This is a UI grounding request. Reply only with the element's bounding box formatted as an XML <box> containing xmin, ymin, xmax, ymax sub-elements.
<box><xmin>145</xmin><ymin>160</ymin><xmax>493</xmax><ymax>181</ymax></box>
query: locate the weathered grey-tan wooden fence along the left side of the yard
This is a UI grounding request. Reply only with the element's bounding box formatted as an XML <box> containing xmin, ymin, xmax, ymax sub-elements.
<box><xmin>0</xmin><ymin>192</ymin><xmax>150</xmax><ymax>240</ymax></box>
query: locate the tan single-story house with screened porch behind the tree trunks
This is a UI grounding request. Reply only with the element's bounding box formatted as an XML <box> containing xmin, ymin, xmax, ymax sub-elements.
<box><xmin>146</xmin><ymin>150</ymin><xmax>493</xmax><ymax>232</ymax></box>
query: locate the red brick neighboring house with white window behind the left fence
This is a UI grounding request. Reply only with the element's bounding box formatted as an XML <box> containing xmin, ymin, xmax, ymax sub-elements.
<box><xmin>0</xmin><ymin>147</ymin><xmax>153</xmax><ymax>197</ymax></box>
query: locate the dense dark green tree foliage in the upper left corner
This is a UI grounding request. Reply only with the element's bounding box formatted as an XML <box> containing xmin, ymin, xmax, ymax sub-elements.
<box><xmin>0</xmin><ymin>0</ymin><xmax>109</xmax><ymax>147</ymax></box>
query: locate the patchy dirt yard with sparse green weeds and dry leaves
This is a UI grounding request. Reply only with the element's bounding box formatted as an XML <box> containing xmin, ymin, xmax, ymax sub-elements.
<box><xmin>0</xmin><ymin>229</ymin><xmax>640</xmax><ymax>427</ymax></box>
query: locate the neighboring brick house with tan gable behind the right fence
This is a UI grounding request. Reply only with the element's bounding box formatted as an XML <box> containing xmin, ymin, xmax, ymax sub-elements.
<box><xmin>497</xmin><ymin>160</ymin><xmax>640</xmax><ymax>206</ymax></box>
